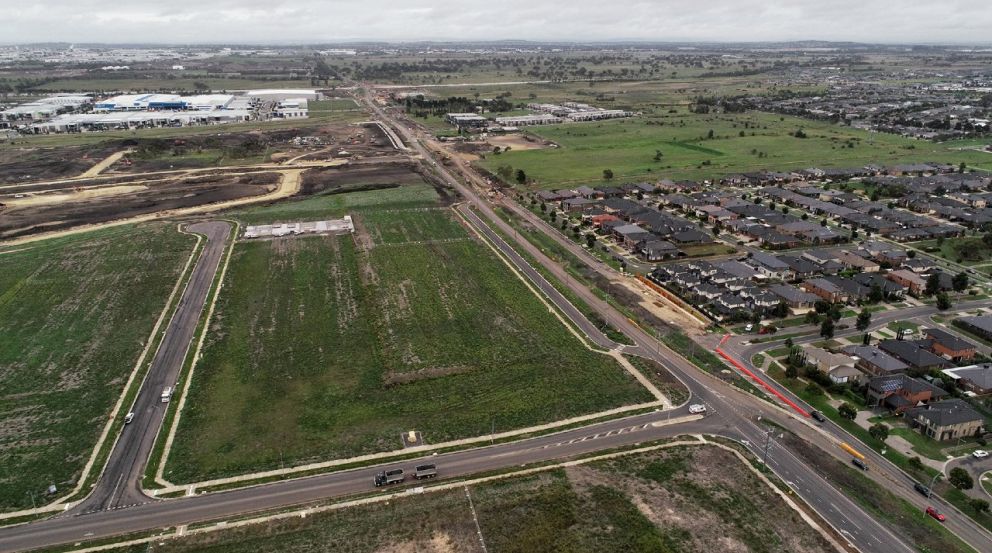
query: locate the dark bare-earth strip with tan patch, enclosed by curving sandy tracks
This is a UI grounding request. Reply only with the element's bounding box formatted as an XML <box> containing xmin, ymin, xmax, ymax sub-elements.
<box><xmin>0</xmin><ymin>173</ymin><xmax>279</xmax><ymax>239</ymax></box>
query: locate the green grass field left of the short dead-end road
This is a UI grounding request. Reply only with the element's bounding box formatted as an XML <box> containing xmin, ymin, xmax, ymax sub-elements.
<box><xmin>0</xmin><ymin>224</ymin><xmax>194</xmax><ymax>510</ymax></box>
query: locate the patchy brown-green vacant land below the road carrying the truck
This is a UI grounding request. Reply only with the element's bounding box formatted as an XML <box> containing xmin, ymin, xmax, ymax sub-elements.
<box><xmin>116</xmin><ymin>446</ymin><xmax>832</xmax><ymax>553</ymax></box>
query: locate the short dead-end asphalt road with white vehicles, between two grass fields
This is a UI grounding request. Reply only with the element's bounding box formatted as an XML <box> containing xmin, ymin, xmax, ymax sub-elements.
<box><xmin>73</xmin><ymin>222</ymin><xmax>231</xmax><ymax>513</ymax></box>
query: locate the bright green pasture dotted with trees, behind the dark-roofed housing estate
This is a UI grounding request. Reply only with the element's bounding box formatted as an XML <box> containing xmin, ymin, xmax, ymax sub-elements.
<box><xmin>484</xmin><ymin>108</ymin><xmax>990</xmax><ymax>188</ymax></box>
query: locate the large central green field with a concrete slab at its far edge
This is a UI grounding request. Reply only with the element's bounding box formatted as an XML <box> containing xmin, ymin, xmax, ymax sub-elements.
<box><xmin>165</xmin><ymin>188</ymin><xmax>652</xmax><ymax>482</ymax></box>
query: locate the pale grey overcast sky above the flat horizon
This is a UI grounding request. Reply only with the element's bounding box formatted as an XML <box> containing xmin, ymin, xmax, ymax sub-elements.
<box><xmin>0</xmin><ymin>0</ymin><xmax>992</xmax><ymax>44</ymax></box>
